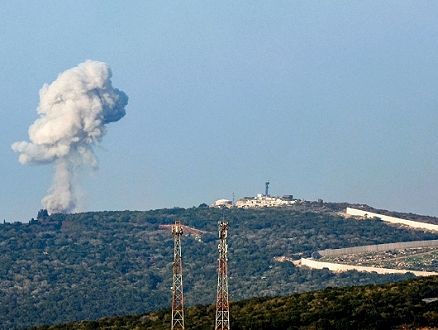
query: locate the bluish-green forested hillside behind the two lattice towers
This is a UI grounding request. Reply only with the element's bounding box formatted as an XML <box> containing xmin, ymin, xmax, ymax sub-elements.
<box><xmin>0</xmin><ymin>207</ymin><xmax>438</xmax><ymax>329</ymax></box>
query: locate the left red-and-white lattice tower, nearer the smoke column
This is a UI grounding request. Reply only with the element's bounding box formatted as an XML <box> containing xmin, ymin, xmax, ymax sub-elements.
<box><xmin>171</xmin><ymin>221</ymin><xmax>184</xmax><ymax>330</ymax></box>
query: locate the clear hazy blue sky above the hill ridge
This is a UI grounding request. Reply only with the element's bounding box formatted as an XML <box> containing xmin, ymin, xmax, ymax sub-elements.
<box><xmin>0</xmin><ymin>0</ymin><xmax>438</xmax><ymax>221</ymax></box>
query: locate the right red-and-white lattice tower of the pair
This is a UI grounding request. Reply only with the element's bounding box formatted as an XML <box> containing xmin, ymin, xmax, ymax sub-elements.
<box><xmin>215</xmin><ymin>221</ymin><xmax>230</xmax><ymax>330</ymax></box>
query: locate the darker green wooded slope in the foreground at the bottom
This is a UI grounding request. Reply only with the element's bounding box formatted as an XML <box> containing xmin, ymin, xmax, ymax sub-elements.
<box><xmin>26</xmin><ymin>276</ymin><xmax>438</xmax><ymax>330</ymax></box>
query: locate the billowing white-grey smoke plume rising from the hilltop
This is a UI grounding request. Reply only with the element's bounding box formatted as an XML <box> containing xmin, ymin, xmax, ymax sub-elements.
<box><xmin>12</xmin><ymin>60</ymin><xmax>128</xmax><ymax>213</ymax></box>
